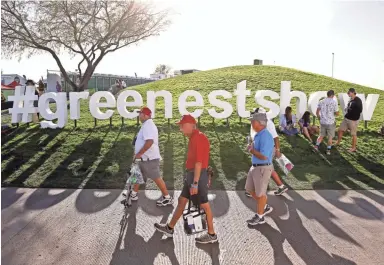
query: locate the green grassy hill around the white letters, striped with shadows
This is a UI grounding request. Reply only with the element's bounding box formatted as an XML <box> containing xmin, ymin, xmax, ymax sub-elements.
<box><xmin>1</xmin><ymin>66</ymin><xmax>384</xmax><ymax>189</ymax></box>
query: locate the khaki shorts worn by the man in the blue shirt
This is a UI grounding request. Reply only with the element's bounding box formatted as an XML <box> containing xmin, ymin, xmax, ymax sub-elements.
<box><xmin>245</xmin><ymin>165</ymin><xmax>273</xmax><ymax>197</ymax></box>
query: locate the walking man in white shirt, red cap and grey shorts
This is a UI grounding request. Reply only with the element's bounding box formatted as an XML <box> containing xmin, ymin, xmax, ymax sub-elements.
<box><xmin>131</xmin><ymin>107</ymin><xmax>173</xmax><ymax>206</ymax></box>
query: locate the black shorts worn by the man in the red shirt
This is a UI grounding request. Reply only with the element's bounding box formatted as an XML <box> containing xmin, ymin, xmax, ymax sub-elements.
<box><xmin>180</xmin><ymin>169</ymin><xmax>208</xmax><ymax>205</ymax></box>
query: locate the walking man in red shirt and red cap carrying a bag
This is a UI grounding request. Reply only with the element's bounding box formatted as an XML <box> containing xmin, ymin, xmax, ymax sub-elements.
<box><xmin>155</xmin><ymin>115</ymin><xmax>218</xmax><ymax>244</ymax></box>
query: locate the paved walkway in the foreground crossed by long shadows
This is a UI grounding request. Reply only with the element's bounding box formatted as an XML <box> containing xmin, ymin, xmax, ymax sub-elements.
<box><xmin>1</xmin><ymin>188</ymin><xmax>384</xmax><ymax>265</ymax></box>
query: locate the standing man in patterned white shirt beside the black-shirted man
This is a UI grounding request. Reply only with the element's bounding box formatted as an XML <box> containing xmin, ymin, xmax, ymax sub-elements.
<box><xmin>315</xmin><ymin>90</ymin><xmax>339</xmax><ymax>155</ymax></box>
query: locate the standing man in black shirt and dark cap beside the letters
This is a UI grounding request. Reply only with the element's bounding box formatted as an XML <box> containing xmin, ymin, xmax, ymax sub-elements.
<box><xmin>336</xmin><ymin>88</ymin><xmax>363</xmax><ymax>152</ymax></box>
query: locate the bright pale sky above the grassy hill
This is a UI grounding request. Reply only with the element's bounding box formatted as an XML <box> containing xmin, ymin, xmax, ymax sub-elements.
<box><xmin>1</xmin><ymin>0</ymin><xmax>384</xmax><ymax>89</ymax></box>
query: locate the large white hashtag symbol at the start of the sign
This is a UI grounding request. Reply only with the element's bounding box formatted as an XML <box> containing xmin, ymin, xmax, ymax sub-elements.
<box><xmin>8</xmin><ymin>86</ymin><xmax>38</xmax><ymax>123</ymax></box>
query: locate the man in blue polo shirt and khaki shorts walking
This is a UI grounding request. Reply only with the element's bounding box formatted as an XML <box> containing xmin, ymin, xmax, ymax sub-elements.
<box><xmin>245</xmin><ymin>113</ymin><xmax>274</xmax><ymax>225</ymax></box>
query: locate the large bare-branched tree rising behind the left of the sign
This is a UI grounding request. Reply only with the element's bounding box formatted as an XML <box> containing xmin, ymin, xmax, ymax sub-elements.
<box><xmin>1</xmin><ymin>0</ymin><xmax>170</xmax><ymax>91</ymax></box>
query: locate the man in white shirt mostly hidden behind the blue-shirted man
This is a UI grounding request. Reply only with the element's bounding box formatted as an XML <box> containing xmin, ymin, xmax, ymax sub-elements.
<box><xmin>249</xmin><ymin>108</ymin><xmax>288</xmax><ymax>197</ymax></box>
